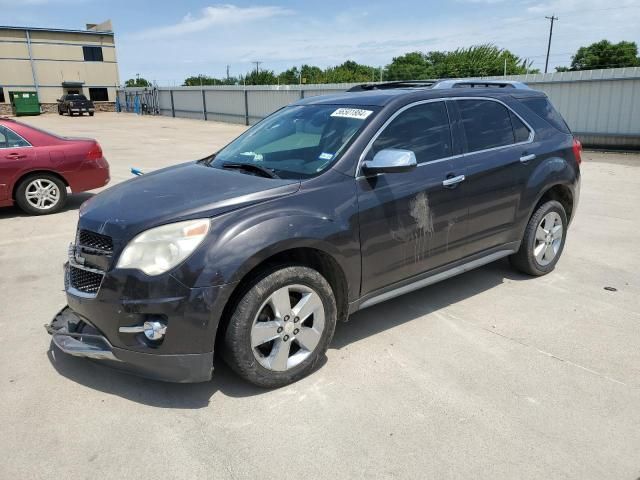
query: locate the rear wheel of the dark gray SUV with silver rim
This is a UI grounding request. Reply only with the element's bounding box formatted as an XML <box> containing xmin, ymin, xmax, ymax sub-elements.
<box><xmin>509</xmin><ymin>200</ymin><xmax>567</xmax><ymax>277</ymax></box>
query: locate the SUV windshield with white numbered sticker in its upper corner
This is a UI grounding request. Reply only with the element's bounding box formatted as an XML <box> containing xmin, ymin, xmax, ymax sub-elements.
<box><xmin>210</xmin><ymin>105</ymin><xmax>374</xmax><ymax>179</ymax></box>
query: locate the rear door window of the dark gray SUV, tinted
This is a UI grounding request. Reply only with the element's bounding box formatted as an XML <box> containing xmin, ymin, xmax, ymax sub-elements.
<box><xmin>456</xmin><ymin>100</ymin><xmax>515</xmax><ymax>152</ymax></box>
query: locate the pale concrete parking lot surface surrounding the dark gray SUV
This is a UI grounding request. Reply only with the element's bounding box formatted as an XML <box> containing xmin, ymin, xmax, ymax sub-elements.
<box><xmin>0</xmin><ymin>113</ymin><xmax>640</xmax><ymax>479</ymax></box>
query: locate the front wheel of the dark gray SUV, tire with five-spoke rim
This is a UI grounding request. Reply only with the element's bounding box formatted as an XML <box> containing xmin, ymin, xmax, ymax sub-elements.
<box><xmin>222</xmin><ymin>266</ymin><xmax>337</xmax><ymax>388</ymax></box>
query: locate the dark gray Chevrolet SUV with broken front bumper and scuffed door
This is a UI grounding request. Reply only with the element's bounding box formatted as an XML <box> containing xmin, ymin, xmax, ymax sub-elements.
<box><xmin>47</xmin><ymin>80</ymin><xmax>581</xmax><ymax>387</ymax></box>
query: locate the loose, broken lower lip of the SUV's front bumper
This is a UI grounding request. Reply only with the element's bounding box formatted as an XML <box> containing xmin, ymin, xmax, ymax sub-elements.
<box><xmin>45</xmin><ymin>307</ymin><xmax>213</xmax><ymax>383</ymax></box>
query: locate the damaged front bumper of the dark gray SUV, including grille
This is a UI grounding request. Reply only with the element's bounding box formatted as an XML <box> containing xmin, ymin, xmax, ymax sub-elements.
<box><xmin>46</xmin><ymin>229</ymin><xmax>235</xmax><ymax>382</ymax></box>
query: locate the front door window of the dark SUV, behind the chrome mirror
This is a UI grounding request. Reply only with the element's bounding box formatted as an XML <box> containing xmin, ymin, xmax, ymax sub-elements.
<box><xmin>367</xmin><ymin>102</ymin><xmax>451</xmax><ymax>163</ymax></box>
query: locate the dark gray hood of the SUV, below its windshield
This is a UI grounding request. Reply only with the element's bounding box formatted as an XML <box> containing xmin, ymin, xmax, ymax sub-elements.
<box><xmin>79</xmin><ymin>162</ymin><xmax>300</xmax><ymax>240</ymax></box>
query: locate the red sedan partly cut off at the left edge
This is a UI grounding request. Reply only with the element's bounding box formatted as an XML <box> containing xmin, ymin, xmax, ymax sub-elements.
<box><xmin>0</xmin><ymin>117</ymin><xmax>109</xmax><ymax>215</ymax></box>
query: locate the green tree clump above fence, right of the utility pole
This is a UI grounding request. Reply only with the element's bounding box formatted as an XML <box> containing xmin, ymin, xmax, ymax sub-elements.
<box><xmin>571</xmin><ymin>40</ymin><xmax>640</xmax><ymax>70</ymax></box>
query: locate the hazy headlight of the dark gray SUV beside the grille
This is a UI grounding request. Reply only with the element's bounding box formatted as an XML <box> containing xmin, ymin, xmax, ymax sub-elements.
<box><xmin>116</xmin><ymin>219</ymin><xmax>210</xmax><ymax>275</ymax></box>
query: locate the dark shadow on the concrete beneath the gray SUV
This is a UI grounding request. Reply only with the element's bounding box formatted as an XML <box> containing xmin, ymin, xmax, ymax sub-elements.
<box><xmin>47</xmin><ymin>261</ymin><xmax>531</xmax><ymax>409</ymax></box>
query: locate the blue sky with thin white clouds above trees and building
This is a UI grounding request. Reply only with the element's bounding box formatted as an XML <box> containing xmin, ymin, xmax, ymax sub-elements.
<box><xmin>0</xmin><ymin>0</ymin><xmax>640</xmax><ymax>85</ymax></box>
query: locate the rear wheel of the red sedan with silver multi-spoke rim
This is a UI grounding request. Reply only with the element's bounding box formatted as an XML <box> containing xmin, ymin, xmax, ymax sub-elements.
<box><xmin>16</xmin><ymin>173</ymin><xmax>67</xmax><ymax>215</ymax></box>
